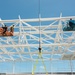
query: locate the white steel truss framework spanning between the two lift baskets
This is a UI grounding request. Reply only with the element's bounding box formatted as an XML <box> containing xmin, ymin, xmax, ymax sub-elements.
<box><xmin>0</xmin><ymin>15</ymin><xmax>75</xmax><ymax>62</ymax></box>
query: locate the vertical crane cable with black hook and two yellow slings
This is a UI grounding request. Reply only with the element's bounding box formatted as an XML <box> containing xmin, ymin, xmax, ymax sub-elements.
<box><xmin>32</xmin><ymin>0</ymin><xmax>48</xmax><ymax>75</ymax></box>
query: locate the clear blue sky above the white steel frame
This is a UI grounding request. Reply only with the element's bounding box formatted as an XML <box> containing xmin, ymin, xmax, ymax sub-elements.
<box><xmin>0</xmin><ymin>0</ymin><xmax>75</xmax><ymax>72</ymax></box>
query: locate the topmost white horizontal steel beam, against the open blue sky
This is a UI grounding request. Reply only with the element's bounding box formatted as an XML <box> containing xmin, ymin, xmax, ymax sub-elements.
<box><xmin>0</xmin><ymin>16</ymin><xmax>75</xmax><ymax>23</ymax></box>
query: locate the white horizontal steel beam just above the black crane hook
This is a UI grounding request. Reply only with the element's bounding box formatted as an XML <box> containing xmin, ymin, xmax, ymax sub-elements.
<box><xmin>0</xmin><ymin>43</ymin><xmax>75</xmax><ymax>48</ymax></box>
